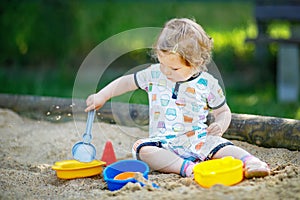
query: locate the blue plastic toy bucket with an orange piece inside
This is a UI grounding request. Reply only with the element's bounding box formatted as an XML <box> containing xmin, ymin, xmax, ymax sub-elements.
<box><xmin>103</xmin><ymin>160</ymin><xmax>149</xmax><ymax>191</ymax></box>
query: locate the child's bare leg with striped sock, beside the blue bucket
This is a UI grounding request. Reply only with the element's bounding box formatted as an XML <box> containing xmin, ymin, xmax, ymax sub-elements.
<box><xmin>139</xmin><ymin>146</ymin><xmax>194</xmax><ymax>176</ymax></box>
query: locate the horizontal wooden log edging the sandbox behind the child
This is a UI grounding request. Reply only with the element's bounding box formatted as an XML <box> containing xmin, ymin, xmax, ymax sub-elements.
<box><xmin>0</xmin><ymin>94</ymin><xmax>300</xmax><ymax>151</ymax></box>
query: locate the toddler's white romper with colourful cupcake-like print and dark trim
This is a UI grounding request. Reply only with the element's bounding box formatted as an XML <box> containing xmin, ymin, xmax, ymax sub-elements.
<box><xmin>133</xmin><ymin>64</ymin><xmax>233</xmax><ymax>160</ymax></box>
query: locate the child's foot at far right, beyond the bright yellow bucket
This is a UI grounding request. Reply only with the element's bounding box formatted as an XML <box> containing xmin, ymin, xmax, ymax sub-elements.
<box><xmin>242</xmin><ymin>155</ymin><xmax>270</xmax><ymax>178</ymax></box>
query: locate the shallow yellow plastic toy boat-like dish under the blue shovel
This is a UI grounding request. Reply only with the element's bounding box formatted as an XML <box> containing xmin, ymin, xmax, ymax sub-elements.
<box><xmin>52</xmin><ymin>160</ymin><xmax>105</xmax><ymax>179</ymax></box>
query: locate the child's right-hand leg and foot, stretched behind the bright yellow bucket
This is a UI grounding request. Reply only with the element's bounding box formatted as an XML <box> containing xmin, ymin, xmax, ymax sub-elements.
<box><xmin>213</xmin><ymin>145</ymin><xmax>270</xmax><ymax>178</ymax></box>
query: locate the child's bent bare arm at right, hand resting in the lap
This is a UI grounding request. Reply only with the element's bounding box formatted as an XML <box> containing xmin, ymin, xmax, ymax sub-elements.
<box><xmin>207</xmin><ymin>103</ymin><xmax>231</xmax><ymax>136</ymax></box>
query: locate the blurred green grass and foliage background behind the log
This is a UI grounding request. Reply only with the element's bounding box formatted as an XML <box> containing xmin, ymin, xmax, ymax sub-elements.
<box><xmin>0</xmin><ymin>0</ymin><xmax>300</xmax><ymax>119</ymax></box>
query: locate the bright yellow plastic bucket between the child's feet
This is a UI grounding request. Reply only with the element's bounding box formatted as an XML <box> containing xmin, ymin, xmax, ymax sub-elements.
<box><xmin>193</xmin><ymin>156</ymin><xmax>244</xmax><ymax>188</ymax></box>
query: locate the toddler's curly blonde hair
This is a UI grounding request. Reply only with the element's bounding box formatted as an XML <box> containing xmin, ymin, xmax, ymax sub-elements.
<box><xmin>153</xmin><ymin>18</ymin><xmax>213</xmax><ymax>73</ymax></box>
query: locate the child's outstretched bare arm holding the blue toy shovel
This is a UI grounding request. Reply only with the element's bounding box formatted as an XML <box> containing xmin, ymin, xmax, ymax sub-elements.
<box><xmin>85</xmin><ymin>74</ymin><xmax>138</xmax><ymax>112</ymax></box>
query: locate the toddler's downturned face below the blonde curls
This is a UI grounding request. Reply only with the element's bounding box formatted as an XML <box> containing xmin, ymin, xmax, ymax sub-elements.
<box><xmin>158</xmin><ymin>52</ymin><xmax>194</xmax><ymax>82</ymax></box>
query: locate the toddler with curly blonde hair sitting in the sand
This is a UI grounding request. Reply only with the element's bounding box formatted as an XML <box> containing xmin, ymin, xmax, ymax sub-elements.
<box><xmin>86</xmin><ymin>18</ymin><xmax>270</xmax><ymax>178</ymax></box>
